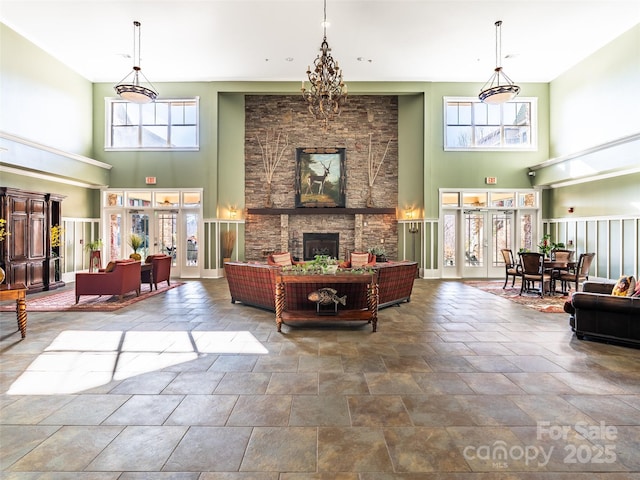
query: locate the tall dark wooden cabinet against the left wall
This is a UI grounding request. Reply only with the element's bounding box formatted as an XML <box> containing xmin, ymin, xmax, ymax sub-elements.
<box><xmin>0</xmin><ymin>187</ymin><xmax>64</xmax><ymax>292</ymax></box>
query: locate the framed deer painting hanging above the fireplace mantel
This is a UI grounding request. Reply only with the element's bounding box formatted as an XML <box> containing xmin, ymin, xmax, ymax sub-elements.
<box><xmin>296</xmin><ymin>148</ymin><xmax>346</xmax><ymax>208</ymax></box>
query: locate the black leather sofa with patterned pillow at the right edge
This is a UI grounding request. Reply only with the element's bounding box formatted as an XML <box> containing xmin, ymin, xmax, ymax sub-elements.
<box><xmin>565</xmin><ymin>281</ymin><xmax>640</xmax><ymax>345</ymax></box>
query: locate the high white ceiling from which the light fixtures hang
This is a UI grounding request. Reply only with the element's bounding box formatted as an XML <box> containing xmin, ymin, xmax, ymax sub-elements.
<box><xmin>0</xmin><ymin>0</ymin><xmax>640</xmax><ymax>84</ymax></box>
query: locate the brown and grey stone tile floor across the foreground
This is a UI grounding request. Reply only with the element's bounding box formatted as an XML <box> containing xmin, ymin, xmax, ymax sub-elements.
<box><xmin>0</xmin><ymin>279</ymin><xmax>640</xmax><ymax>480</ymax></box>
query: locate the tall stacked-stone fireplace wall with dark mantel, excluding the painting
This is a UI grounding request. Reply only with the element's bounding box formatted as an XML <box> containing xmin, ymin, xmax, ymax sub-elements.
<box><xmin>244</xmin><ymin>95</ymin><xmax>398</xmax><ymax>261</ymax></box>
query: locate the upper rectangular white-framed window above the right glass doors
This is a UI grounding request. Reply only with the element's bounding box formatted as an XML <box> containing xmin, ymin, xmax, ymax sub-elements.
<box><xmin>444</xmin><ymin>97</ymin><xmax>538</xmax><ymax>151</ymax></box>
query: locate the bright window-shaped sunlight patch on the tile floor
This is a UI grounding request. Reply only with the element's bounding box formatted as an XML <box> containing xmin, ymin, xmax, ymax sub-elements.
<box><xmin>7</xmin><ymin>330</ymin><xmax>269</xmax><ymax>395</ymax></box>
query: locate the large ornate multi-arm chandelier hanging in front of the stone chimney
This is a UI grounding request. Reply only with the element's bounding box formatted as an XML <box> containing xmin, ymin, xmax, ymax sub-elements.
<box><xmin>302</xmin><ymin>0</ymin><xmax>347</xmax><ymax>127</ymax></box>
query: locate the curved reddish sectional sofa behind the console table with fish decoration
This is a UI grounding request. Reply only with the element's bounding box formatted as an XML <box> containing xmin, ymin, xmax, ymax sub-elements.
<box><xmin>224</xmin><ymin>261</ymin><xmax>418</xmax><ymax>312</ymax></box>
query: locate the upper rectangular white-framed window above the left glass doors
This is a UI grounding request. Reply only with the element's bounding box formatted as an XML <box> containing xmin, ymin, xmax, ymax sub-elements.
<box><xmin>105</xmin><ymin>98</ymin><xmax>199</xmax><ymax>150</ymax></box>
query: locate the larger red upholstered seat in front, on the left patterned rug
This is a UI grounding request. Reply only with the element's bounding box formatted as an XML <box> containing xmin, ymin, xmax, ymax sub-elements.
<box><xmin>76</xmin><ymin>260</ymin><xmax>140</xmax><ymax>303</ymax></box>
